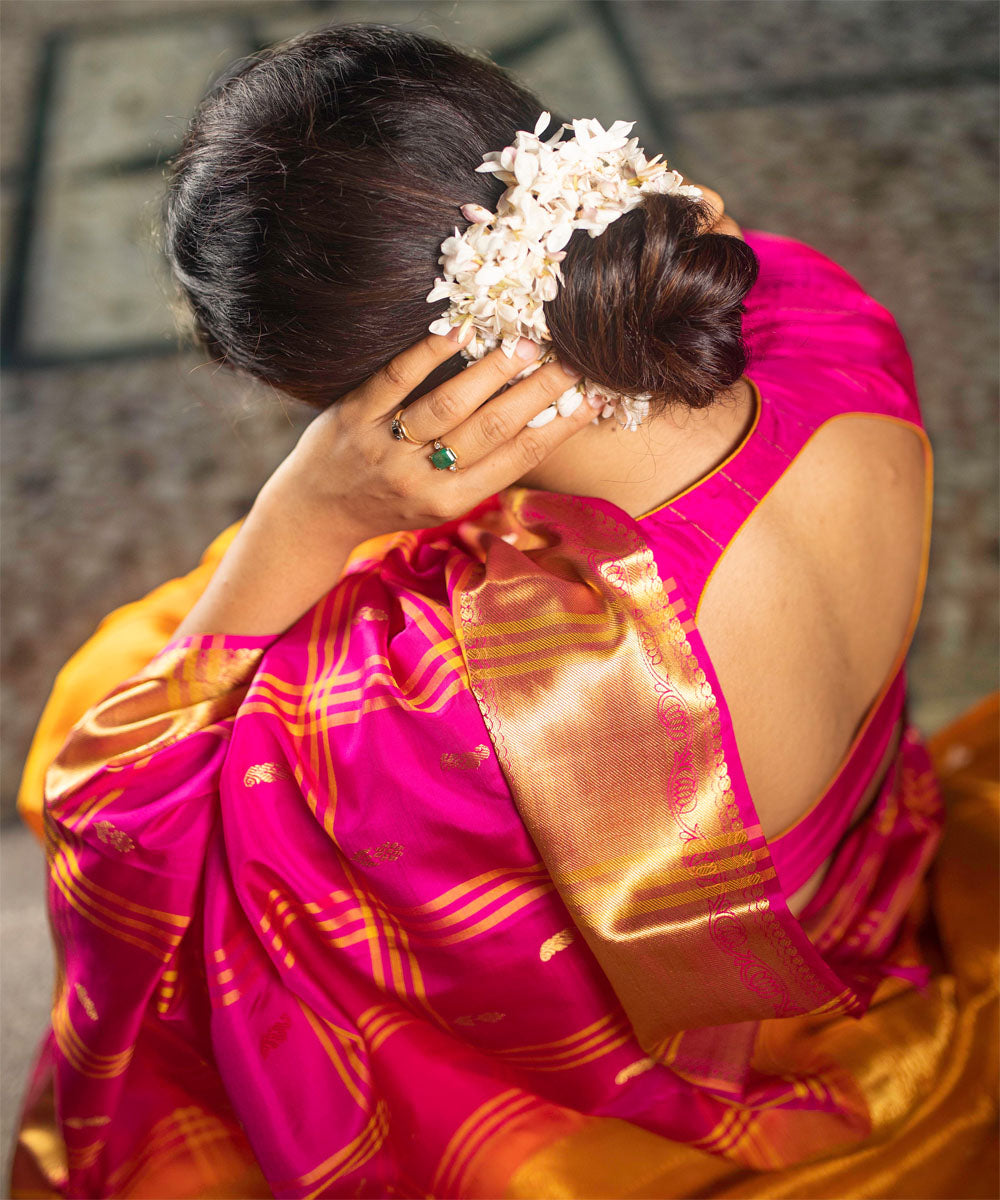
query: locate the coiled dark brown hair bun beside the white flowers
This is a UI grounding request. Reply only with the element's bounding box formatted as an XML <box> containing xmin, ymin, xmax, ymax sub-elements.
<box><xmin>545</xmin><ymin>196</ymin><xmax>759</xmax><ymax>408</ymax></box>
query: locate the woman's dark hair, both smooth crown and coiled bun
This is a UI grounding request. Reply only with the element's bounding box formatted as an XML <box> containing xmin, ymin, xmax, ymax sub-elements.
<box><xmin>163</xmin><ymin>24</ymin><xmax>756</xmax><ymax>408</ymax></box>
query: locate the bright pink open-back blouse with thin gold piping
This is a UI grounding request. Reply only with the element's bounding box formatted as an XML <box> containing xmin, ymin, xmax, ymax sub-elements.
<box><xmin>636</xmin><ymin>232</ymin><xmax>933</xmax><ymax>895</ymax></box>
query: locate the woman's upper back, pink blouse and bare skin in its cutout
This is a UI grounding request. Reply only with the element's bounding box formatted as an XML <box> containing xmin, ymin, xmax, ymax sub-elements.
<box><xmin>637</xmin><ymin>226</ymin><xmax>932</xmax><ymax>902</ymax></box>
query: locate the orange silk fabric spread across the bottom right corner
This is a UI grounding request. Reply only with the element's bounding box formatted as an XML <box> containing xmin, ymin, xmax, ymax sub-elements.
<box><xmin>505</xmin><ymin>694</ymin><xmax>1000</xmax><ymax>1200</ymax></box>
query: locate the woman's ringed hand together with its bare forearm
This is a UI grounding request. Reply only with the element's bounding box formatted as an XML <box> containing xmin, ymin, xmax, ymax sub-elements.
<box><xmin>174</xmin><ymin>335</ymin><xmax>594</xmax><ymax>638</ymax></box>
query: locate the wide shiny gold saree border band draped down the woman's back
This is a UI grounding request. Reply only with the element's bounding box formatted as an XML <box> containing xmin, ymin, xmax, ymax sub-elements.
<box><xmin>454</xmin><ymin>488</ymin><xmax>843</xmax><ymax>1055</ymax></box>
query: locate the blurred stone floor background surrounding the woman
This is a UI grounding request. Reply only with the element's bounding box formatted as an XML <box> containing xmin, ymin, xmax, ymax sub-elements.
<box><xmin>0</xmin><ymin>0</ymin><xmax>998</xmax><ymax>1160</ymax></box>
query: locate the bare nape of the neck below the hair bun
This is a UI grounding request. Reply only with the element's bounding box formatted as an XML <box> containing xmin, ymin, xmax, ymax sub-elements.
<box><xmin>517</xmin><ymin>378</ymin><xmax>756</xmax><ymax>517</ymax></box>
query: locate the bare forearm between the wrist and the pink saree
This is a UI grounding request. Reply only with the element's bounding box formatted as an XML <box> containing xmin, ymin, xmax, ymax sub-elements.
<box><xmin>174</xmin><ymin>460</ymin><xmax>367</xmax><ymax>637</ymax></box>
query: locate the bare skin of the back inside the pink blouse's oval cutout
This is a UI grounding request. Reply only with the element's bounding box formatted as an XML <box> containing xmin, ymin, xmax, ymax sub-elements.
<box><xmin>697</xmin><ymin>414</ymin><xmax>928</xmax><ymax>834</ymax></box>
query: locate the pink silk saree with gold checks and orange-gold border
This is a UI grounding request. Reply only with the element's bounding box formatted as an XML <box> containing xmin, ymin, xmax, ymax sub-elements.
<box><xmin>13</xmin><ymin>231</ymin><xmax>996</xmax><ymax>1198</ymax></box>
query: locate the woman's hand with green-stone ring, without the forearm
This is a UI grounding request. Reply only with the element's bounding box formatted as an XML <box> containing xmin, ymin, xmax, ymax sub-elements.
<box><xmin>280</xmin><ymin>335</ymin><xmax>594</xmax><ymax>541</ymax></box>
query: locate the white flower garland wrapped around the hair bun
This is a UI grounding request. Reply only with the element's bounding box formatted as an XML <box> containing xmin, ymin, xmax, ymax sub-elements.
<box><xmin>427</xmin><ymin>113</ymin><xmax>702</xmax><ymax>430</ymax></box>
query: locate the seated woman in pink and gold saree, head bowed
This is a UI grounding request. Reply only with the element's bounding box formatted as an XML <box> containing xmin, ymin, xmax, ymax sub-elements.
<box><xmin>14</xmin><ymin>26</ymin><xmax>995</xmax><ymax>1196</ymax></box>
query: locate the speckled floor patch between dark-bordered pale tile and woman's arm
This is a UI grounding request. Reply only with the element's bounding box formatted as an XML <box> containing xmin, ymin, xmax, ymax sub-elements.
<box><xmin>0</xmin><ymin>354</ymin><xmax>306</xmax><ymax>814</ymax></box>
